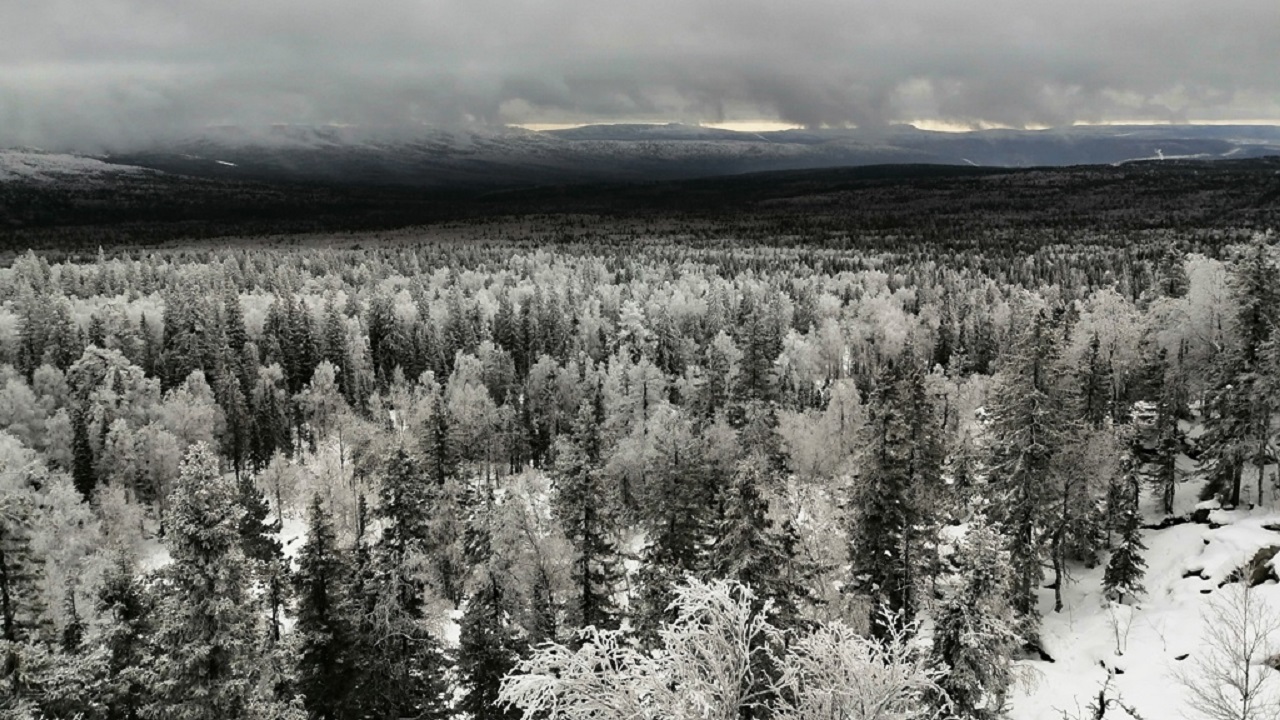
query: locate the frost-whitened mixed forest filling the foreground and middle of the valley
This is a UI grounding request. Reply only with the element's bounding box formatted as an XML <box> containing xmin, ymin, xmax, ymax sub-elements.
<box><xmin>0</xmin><ymin>162</ymin><xmax>1280</xmax><ymax>720</ymax></box>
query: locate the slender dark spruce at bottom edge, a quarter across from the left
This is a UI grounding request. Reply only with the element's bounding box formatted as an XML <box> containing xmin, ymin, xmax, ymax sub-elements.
<box><xmin>293</xmin><ymin>496</ymin><xmax>358</xmax><ymax>720</ymax></box>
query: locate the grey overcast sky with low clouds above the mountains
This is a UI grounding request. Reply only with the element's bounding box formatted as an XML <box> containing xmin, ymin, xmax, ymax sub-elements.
<box><xmin>0</xmin><ymin>0</ymin><xmax>1280</xmax><ymax>149</ymax></box>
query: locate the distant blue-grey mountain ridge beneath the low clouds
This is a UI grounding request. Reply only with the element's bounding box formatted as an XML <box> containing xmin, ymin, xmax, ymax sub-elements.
<box><xmin>90</xmin><ymin>124</ymin><xmax>1280</xmax><ymax>188</ymax></box>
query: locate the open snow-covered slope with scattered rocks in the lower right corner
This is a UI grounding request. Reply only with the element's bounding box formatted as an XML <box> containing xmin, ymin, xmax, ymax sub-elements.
<box><xmin>1010</xmin><ymin>476</ymin><xmax>1280</xmax><ymax>720</ymax></box>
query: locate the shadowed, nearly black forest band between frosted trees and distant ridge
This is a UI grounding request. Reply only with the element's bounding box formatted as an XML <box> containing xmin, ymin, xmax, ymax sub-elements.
<box><xmin>0</xmin><ymin>158</ymin><xmax>1280</xmax><ymax>261</ymax></box>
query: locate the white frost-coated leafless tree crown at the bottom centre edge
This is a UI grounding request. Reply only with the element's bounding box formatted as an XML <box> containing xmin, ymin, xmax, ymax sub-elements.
<box><xmin>499</xmin><ymin>580</ymin><xmax>937</xmax><ymax>720</ymax></box>
